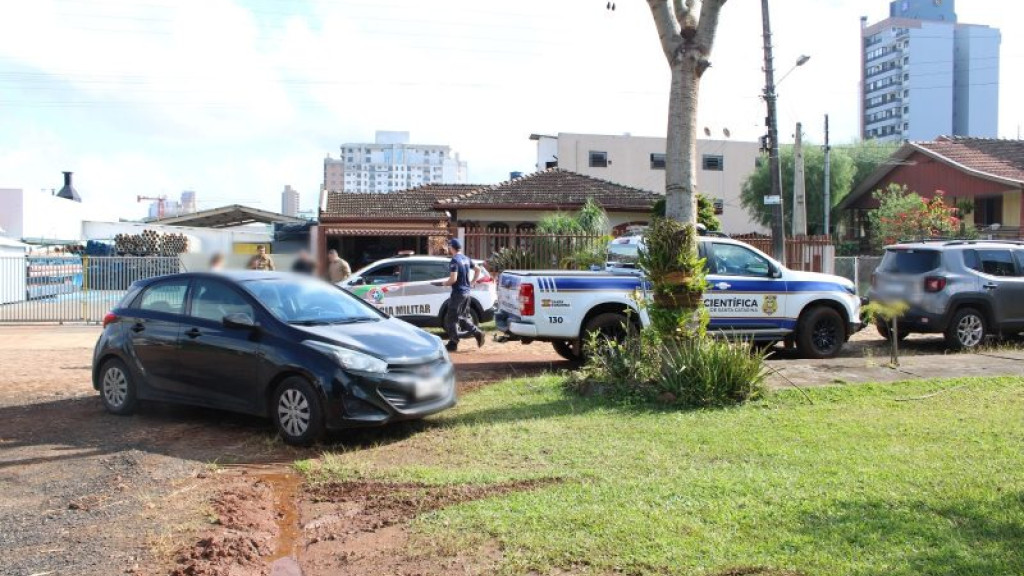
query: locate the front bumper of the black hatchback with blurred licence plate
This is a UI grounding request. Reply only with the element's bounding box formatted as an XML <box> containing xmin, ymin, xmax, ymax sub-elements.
<box><xmin>327</xmin><ymin>360</ymin><xmax>458</xmax><ymax>428</ymax></box>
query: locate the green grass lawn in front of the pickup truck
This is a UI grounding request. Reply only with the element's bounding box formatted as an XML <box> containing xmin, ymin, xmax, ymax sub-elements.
<box><xmin>301</xmin><ymin>376</ymin><xmax>1024</xmax><ymax>576</ymax></box>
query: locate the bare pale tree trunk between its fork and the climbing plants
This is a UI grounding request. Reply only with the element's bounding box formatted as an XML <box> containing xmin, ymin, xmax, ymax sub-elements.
<box><xmin>665</xmin><ymin>58</ymin><xmax>700</xmax><ymax>224</ymax></box>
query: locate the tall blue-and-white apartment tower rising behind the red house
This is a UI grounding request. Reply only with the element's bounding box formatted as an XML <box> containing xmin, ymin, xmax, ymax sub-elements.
<box><xmin>861</xmin><ymin>0</ymin><xmax>1001</xmax><ymax>141</ymax></box>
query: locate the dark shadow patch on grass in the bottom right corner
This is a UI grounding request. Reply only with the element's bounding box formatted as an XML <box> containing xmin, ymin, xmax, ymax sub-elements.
<box><xmin>790</xmin><ymin>492</ymin><xmax>1024</xmax><ymax>576</ymax></box>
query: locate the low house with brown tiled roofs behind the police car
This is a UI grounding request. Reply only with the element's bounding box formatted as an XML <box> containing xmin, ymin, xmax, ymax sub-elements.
<box><xmin>317</xmin><ymin>168</ymin><xmax>662</xmax><ymax>268</ymax></box>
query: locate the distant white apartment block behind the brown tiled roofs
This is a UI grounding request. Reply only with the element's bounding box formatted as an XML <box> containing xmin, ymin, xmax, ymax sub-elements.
<box><xmin>324</xmin><ymin>131</ymin><xmax>467</xmax><ymax>193</ymax></box>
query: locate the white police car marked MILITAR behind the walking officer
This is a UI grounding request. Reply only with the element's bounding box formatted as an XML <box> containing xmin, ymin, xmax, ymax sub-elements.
<box><xmin>338</xmin><ymin>256</ymin><xmax>497</xmax><ymax>327</ymax></box>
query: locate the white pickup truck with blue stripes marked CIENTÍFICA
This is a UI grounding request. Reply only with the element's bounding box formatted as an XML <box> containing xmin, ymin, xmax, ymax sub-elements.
<box><xmin>495</xmin><ymin>237</ymin><xmax>861</xmax><ymax>360</ymax></box>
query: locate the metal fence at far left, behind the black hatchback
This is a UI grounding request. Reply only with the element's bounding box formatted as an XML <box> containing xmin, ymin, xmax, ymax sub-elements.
<box><xmin>0</xmin><ymin>256</ymin><xmax>182</xmax><ymax>323</ymax></box>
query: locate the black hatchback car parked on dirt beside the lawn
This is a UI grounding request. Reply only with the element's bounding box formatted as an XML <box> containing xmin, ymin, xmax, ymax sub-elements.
<box><xmin>92</xmin><ymin>272</ymin><xmax>456</xmax><ymax>445</ymax></box>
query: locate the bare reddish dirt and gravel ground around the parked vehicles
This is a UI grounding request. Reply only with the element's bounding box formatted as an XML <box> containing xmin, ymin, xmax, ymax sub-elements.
<box><xmin>0</xmin><ymin>326</ymin><xmax>1024</xmax><ymax>576</ymax></box>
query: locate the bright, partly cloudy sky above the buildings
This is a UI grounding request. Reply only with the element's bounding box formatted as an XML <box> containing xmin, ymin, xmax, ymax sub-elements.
<box><xmin>0</xmin><ymin>0</ymin><xmax>1024</xmax><ymax>218</ymax></box>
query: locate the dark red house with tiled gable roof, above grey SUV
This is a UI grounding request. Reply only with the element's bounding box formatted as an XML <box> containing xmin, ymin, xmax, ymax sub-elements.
<box><xmin>837</xmin><ymin>136</ymin><xmax>1024</xmax><ymax>242</ymax></box>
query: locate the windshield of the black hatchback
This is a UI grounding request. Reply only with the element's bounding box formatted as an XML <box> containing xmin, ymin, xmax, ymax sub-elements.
<box><xmin>242</xmin><ymin>278</ymin><xmax>383</xmax><ymax>325</ymax></box>
